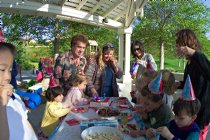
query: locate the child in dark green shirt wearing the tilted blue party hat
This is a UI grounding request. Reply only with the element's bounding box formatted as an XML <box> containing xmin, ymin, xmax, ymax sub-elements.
<box><xmin>127</xmin><ymin>73</ymin><xmax>173</xmax><ymax>136</ymax></box>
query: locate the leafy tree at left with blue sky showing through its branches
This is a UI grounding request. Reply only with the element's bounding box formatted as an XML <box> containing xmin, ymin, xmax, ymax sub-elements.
<box><xmin>2</xmin><ymin>14</ymin><xmax>68</xmax><ymax>53</ymax></box>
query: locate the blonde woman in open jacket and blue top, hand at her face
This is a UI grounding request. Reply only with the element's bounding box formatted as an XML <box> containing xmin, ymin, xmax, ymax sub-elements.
<box><xmin>85</xmin><ymin>43</ymin><xmax>123</xmax><ymax>97</ymax></box>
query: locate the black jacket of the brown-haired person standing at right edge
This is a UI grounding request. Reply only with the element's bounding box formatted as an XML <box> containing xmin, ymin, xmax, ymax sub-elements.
<box><xmin>182</xmin><ymin>52</ymin><xmax>210</xmax><ymax>129</ymax></box>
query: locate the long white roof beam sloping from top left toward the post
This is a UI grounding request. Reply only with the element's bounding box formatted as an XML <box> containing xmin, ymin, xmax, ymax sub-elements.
<box><xmin>0</xmin><ymin>0</ymin><xmax>124</xmax><ymax>28</ymax></box>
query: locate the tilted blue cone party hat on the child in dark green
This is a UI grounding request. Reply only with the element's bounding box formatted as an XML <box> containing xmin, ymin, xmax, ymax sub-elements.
<box><xmin>148</xmin><ymin>72</ymin><xmax>163</xmax><ymax>95</ymax></box>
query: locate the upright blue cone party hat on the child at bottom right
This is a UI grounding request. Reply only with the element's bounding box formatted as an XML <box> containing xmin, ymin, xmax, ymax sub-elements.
<box><xmin>180</xmin><ymin>75</ymin><xmax>196</xmax><ymax>101</ymax></box>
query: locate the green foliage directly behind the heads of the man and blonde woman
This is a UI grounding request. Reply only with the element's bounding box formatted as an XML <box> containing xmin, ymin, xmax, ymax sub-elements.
<box><xmin>59</xmin><ymin>21</ymin><xmax>118</xmax><ymax>54</ymax></box>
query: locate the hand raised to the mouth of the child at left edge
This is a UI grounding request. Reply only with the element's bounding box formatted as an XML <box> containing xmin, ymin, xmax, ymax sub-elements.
<box><xmin>0</xmin><ymin>84</ymin><xmax>13</xmax><ymax>106</ymax></box>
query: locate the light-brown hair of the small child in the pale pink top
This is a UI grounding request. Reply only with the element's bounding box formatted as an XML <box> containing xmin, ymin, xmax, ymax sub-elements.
<box><xmin>69</xmin><ymin>74</ymin><xmax>89</xmax><ymax>87</ymax></box>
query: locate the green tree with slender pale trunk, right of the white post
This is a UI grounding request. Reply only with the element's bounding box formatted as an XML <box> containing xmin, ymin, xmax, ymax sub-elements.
<box><xmin>133</xmin><ymin>0</ymin><xmax>210</xmax><ymax>69</ymax></box>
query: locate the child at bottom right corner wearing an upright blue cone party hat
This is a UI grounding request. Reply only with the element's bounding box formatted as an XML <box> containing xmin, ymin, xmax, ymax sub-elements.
<box><xmin>156</xmin><ymin>75</ymin><xmax>201</xmax><ymax>140</ymax></box>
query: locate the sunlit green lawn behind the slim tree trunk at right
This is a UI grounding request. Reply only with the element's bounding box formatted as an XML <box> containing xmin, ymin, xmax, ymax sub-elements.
<box><xmin>156</xmin><ymin>58</ymin><xmax>187</xmax><ymax>72</ymax></box>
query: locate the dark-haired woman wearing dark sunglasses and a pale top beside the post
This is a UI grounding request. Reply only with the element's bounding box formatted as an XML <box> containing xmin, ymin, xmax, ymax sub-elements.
<box><xmin>130</xmin><ymin>41</ymin><xmax>157</xmax><ymax>78</ymax></box>
